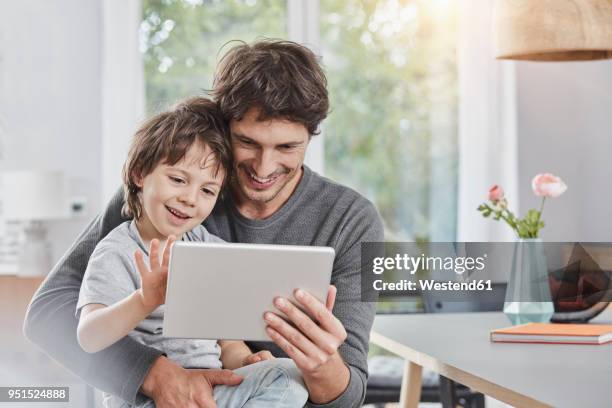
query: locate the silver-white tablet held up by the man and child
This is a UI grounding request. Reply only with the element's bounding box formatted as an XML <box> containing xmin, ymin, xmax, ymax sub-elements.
<box><xmin>163</xmin><ymin>242</ymin><xmax>335</xmax><ymax>341</ymax></box>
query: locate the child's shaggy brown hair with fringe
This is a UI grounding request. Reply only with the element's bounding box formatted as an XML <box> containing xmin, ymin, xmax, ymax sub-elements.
<box><xmin>122</xmin><ymin>97</ymin><xmax>232</xmax><ymax>219</ymax></box>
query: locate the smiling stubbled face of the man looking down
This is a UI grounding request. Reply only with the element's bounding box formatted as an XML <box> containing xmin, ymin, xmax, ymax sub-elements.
<box><xmin>230</xmin><ymin>108</ymin><xmax>309</xmax><ymax>213</ymax></box>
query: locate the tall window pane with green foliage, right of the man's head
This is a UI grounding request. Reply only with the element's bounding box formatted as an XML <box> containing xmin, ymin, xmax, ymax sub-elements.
<box><xmin>320</xmin><ymin>0</ymin><xmax>458</xmax><ymax>241</ymax></box>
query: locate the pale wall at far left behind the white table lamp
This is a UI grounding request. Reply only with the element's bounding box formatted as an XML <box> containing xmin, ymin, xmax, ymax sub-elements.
<box><xmin>0</xmin><ymin>0</ymin><xmax>102</xmax><ymax>260</ymax></box>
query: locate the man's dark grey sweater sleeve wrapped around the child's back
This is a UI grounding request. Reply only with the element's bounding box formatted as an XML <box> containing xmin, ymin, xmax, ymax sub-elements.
<box><xmin>24</xmin><ymin>191</ymin><xmax>161</xmax><ymax>404</ymax></box>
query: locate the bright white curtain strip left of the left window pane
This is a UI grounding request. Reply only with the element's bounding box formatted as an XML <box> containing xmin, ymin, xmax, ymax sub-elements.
<box><xmin>101</xmin><ymin>0</ymin><xmax>145</xmax><ymax>205</ymax></box>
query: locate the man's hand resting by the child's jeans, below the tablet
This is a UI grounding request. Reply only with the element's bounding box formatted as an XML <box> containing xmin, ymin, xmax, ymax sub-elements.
<box><xmin>141</xmin><ymin>357</ymin><xmax>242</xmax><ymax>408</ymax></box>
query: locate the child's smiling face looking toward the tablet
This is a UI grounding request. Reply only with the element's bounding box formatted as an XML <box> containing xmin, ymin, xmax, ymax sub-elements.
<box><xmin>135</xmin><ymin>142</ymin><xmax>225</xmax><ymax>241</ymax></box>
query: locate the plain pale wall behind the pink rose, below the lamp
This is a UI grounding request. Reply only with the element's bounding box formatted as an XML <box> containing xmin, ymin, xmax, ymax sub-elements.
<box><xmin>517</xmin><ymin>61</ymin><xmax>612</xmax><ymax>241</ymax></box>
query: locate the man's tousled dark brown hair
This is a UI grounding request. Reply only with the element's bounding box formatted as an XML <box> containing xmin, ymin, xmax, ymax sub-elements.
<box><xmin>212</xmin><ymin>39</ymin><xmax>329</xmax><ymax>136</ymax></box>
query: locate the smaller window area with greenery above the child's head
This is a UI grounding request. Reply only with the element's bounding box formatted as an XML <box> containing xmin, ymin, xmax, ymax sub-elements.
<box><xmin>140</xmin><ymin>0</ymin><xmax>286</xmax><ymax>113</ymax></box>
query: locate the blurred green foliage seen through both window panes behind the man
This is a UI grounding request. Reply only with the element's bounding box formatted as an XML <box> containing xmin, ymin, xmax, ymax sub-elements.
<box><xmin>140</xmin><ymin>0</ymin><xmax>458</xmax><ymax>241</ymax></box>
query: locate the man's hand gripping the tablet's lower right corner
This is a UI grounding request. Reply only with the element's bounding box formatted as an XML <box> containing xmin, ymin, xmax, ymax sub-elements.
<box><xmin>264</xmin><ymin>286</ymin><xmax>350</xmax><ymax>403</ymax></box>
